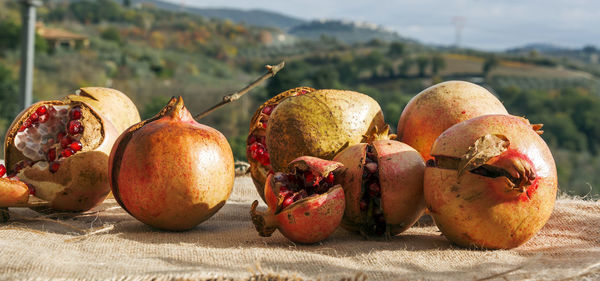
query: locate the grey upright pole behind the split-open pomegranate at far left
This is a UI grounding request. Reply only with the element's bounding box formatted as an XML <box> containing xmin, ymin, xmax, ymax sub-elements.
<box><xmin>19</xmin><ymin>0</ymin><xmax>42</xmax><ymax>109</ymax></box>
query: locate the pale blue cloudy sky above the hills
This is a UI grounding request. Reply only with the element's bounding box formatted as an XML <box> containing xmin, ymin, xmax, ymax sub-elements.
<box><xmin>169</xmin><ymin>0</ymin><xmax>600</xmax><ymax>50</ymax></box>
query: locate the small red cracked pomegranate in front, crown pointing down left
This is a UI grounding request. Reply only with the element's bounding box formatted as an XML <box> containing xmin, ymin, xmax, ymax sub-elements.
<box><xmin>250</xmin><ymin>156</ymin><xmax>345</xmax><ymax>244</ymax></box>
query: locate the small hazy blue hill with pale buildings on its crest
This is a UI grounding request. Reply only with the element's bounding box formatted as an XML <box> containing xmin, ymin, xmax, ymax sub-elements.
<box><xmin>289</xmin><ymin>20</ymin><xmax>411</xmax><ymax>43</ymax></box>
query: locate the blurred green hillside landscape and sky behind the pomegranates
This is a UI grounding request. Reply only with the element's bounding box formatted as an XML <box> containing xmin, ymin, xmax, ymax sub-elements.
<box><xmin>0</xmin><ymin>0</ymin><xmax>600</xmax><ymax>196</ymax></box>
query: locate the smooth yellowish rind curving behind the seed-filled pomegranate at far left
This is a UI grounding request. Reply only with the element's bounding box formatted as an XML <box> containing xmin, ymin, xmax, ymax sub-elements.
<box><xmin>67</xmin><ymin>87</ymin><xmax>140</xmax><ymax>133</ymax></box>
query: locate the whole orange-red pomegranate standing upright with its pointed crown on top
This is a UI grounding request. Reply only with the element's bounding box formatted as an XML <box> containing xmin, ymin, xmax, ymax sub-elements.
<box><xmin>109</xmin><ymin>97</ymin><xmax>234</xmax><ymax>230</ymax></box>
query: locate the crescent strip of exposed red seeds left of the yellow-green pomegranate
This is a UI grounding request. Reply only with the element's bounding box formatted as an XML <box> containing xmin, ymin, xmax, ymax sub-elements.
<box><xmin>246</xmin><ymin>87</ymin><xmax>315</xmax><ymax>200</ymax></box>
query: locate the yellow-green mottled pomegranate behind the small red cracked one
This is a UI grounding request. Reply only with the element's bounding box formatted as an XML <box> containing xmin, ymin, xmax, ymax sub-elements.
<box><xmin>266</xmin><ymin>90</ymin><xmax>385</xmax><ymax>172</ymax></box>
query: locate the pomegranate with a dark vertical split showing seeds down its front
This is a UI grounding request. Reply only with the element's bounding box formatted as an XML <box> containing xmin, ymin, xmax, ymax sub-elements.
<box><xmin>333</xmin><ymin>127</ymin><xmax>425</xmax><ymax>237</ymax></box>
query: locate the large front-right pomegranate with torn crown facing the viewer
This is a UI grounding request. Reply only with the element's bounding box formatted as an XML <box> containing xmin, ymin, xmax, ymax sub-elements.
<box><xmin>424</xmin><ymin>112</ymin><xmax>557</xmax><ymax>249</ymax></box>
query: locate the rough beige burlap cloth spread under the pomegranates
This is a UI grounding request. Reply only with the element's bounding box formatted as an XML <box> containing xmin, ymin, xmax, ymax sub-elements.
<box><xmin>0</xmin><ymin>177</ymin><xmax>600</xmax><ymax>280</ymax></box>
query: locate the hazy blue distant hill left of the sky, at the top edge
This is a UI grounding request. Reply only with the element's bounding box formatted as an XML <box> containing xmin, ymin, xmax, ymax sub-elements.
<box><xmin>133</xmin><ymin>0</ymin><xmax>306</xmax><ymax>31</ymax></box>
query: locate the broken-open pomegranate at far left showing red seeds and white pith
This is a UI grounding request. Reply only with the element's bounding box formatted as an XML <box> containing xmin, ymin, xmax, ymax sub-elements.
<box><xmin>4</xmin><ymin>99</ymin><xmax>117</xmax><ymax>211</ymax></box>
